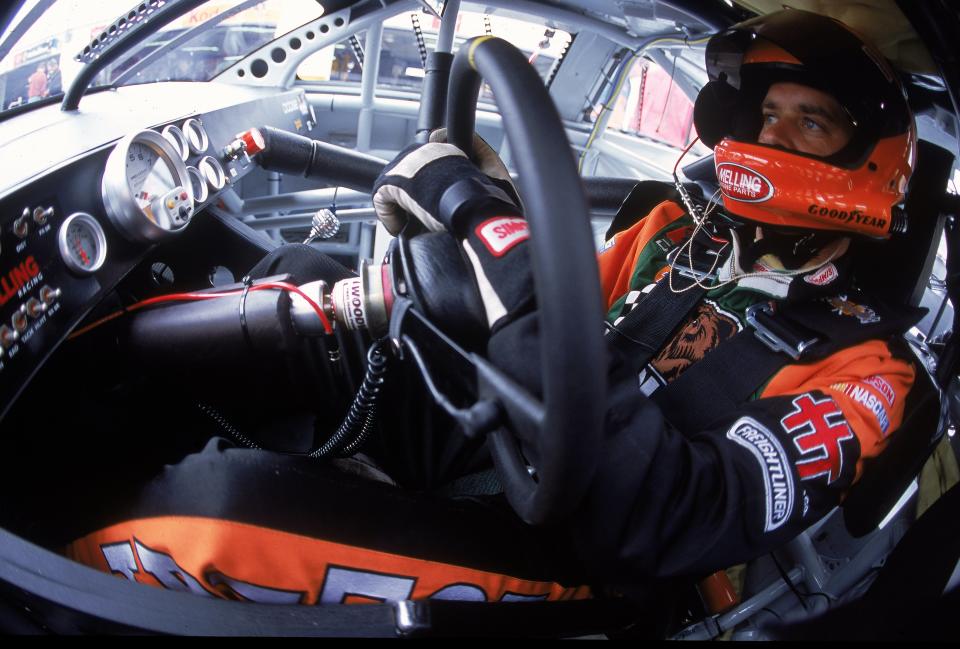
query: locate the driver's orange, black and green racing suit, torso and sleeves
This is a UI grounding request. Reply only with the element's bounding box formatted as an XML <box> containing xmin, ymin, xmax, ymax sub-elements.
<box><xmin>484</xmin><ymin>201</ymin><xmax>915</xmax><ymax>583</ymax></box>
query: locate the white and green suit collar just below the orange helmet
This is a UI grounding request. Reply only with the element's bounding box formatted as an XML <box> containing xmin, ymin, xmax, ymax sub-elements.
<box><xmin>717</xmin><ymin>230</ymin><xmax>850</xmax><ymax>300</ymax></box>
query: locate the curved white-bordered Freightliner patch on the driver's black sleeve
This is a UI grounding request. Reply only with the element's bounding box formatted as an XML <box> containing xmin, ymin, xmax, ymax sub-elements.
<box><xmin>727</xmin><ymin>417</ymin><xmax>795</xmax><ymax>532</ymax></box>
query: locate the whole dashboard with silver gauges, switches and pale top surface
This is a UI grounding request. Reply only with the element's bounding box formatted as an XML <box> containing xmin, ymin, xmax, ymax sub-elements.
<box><xmin>0</xmin><ymin>84</ymin><xmax>315</xmax><ymax>418</ymax></box>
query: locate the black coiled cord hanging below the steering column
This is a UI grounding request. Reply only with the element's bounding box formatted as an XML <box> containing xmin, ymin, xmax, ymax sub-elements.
<box><xmin>310</xmin><ymin>338</ymin><xmax>389</xmax><ymax>458</ymax></box>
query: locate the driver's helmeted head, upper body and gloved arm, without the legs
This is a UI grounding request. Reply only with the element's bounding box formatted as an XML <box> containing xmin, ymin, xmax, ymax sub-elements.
<box><xmin>374</xmin><ymin>10</ymin><xmax>916</xmax><ymax>580</ymax></box>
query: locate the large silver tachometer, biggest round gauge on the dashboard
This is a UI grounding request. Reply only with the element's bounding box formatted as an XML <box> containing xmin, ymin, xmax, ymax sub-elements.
<box><xmin>101</xmin><ymin>131</ymin><xmax>193</xmax><ymax>242</ymax></box>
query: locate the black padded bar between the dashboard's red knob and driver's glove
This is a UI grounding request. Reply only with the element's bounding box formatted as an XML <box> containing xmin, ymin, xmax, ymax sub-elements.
<box><xmin>256</xmin><ymin>126</ymin><xmax>387</xmax><ymax>192</ymax></box>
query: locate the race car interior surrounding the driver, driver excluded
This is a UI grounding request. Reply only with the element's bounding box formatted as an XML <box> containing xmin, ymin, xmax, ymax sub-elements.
<box><xmin>0</xmin><ymin>0</ymin><xmax>960</xmax><ymax>640</ymax></box>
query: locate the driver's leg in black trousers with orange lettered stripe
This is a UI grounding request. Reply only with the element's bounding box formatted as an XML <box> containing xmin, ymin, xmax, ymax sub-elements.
<box><xmin>67</xmin><ymin>438</ymin><xmax>589</xmax><ymax>604</ymax></box>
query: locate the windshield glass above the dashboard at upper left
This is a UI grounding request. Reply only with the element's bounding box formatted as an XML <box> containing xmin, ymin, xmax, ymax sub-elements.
<box><xmin>0</xmin><ymin>0</ymin><xmax>323</xmax><ymax>111</ymax></box>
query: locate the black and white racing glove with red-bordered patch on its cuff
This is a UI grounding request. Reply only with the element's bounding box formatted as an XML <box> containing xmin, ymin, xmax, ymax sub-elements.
<box><xmin>373</xmin><ymin>139</ymin><xmax>532</xmax><ymax>328</ymax></box>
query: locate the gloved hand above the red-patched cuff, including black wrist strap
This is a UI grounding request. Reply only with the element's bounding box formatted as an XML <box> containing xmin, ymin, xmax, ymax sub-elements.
<box><xmin>373</xmin><ymin>142</ymin><xmax>521</xmax><ymax>238</ymax></box>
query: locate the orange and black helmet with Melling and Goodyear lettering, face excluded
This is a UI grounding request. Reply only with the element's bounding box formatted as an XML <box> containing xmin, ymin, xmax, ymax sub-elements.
<box><xmin>694</xmin><ymin>9</ymin><xmax>916</xmax><ymax>238</ymax></box>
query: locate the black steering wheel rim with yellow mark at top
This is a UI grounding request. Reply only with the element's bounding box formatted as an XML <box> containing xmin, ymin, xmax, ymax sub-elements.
<box><xmin>447</xmin><ymin>37</ymin><xmax>606</xmax><ymax>524</ymax></box>
